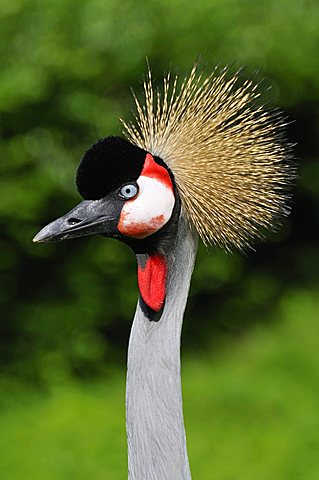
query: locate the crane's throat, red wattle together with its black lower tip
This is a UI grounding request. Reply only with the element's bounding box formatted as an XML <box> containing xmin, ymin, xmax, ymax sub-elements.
<box><xmin>137</xmin><ymin>253</ymin><xmax>167</xmax><ymax>321</ymax></box>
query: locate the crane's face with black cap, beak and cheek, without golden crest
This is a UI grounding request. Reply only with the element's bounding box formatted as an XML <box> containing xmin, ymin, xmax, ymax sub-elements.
<box><xmin>34</xmin><ymin>137</ymin><xmax>179</xmax><ymax>248</ymax></box>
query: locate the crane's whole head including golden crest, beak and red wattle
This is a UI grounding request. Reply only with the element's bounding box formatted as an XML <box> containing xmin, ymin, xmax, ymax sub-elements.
<box><xmin>34</xmin><ymin>65</ymin><xmax>296</xmax><ymax>318</ymax></box>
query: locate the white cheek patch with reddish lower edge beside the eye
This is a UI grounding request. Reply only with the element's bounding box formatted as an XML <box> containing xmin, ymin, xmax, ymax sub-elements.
<box><xmin>118</xmin><ymin>175</ymin><xmax>175</xmax><ymax>238</ymax></box>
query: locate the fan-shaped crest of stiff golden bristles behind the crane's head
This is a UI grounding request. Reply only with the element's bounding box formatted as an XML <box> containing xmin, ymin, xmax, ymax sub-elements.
<box><xmin>122</xmin><ymin>65</ymin><xmax>295</xmax><ymax>250</ymax></box>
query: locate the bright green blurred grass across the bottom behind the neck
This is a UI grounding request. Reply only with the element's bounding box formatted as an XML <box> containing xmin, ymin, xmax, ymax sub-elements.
<box><xmin>0</xmin><ymin>289</ymin><xmax>319</xmax><ymax>480</ymax></box>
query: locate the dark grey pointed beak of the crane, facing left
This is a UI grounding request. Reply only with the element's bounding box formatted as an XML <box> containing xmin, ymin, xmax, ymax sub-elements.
<box><xmin>33</xmin><ymin>199</ymin><xmax>119</xmax><ymax>243</ymax></box>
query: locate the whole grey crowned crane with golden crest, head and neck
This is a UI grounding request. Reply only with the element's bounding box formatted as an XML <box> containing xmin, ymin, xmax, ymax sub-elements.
<box><xmin>34</xmin><ymin>67</ymin><xmax>295</xmax><ymax>480</ymax></box>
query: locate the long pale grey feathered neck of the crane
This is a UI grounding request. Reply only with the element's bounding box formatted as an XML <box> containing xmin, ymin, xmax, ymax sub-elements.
<box><xmin>126</xmin><ymin>213</ymin><xmax>197</xmax><ymax>480</ymax></box>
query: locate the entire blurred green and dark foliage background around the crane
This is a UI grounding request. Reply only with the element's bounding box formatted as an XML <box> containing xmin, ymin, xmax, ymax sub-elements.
<box><xmin>0</xmin><ymin>0</ymin><xmax>319</xmax><ymax>480</ymax></box>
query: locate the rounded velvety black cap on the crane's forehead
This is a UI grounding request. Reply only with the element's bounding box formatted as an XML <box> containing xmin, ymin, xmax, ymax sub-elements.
<box><xmin>76</xmin><ymin>137</ymin><xmax>147</xmax><ymax>200</ymax></box>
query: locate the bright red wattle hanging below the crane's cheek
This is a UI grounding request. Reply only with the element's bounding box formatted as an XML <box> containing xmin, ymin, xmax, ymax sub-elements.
<box><xmin>137</xmin><ymin>255</ymin><xmax>167</xmax><ymax>312</ymax></box>
